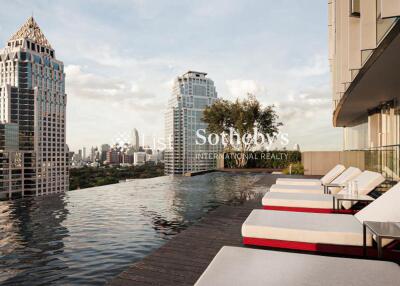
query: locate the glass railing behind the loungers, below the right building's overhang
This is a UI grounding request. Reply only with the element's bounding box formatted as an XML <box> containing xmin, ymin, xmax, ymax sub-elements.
<box><xmin>343</xmin><ymin>145</ymin><xmax>400</xmax><ymax>181</ymax></box>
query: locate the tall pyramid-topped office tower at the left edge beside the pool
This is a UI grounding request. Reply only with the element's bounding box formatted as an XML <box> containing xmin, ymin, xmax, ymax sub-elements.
<box><xmin>0</xmin><ymin>17</ymin><xmax>69</xmax><ymax>197</ymax></box>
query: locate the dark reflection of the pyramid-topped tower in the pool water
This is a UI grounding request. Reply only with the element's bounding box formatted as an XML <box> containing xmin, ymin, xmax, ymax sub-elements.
<box><xmin>0</xmin><ymin>195</ymin><xmax>69</xmax><ymax>285</ymax></box>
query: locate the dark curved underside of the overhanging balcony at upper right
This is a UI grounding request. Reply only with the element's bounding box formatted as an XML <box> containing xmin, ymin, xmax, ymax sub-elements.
<box><xmin>333</xmin><ymin>19</ymin><xmax>400</xmax><ymax>127</ymax></box>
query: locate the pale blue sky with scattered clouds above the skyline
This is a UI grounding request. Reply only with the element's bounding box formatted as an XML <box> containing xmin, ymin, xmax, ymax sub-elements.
<box><xmin>0</xmin><ymin>0</ymin><xmax>342</xmax><ymax>151</ymax></box>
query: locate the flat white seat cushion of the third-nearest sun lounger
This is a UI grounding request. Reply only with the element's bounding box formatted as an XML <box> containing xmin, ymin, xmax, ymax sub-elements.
<box><xmin>262</xmin><ymin>192</ymin><xmax>333</xmax><ymax>209</ymax></box>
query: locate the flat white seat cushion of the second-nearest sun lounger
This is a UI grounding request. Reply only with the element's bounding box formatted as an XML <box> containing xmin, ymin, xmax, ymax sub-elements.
<box><xmin>242</xmin><ymin>210</ymin><xmax>372</xmax><ymax>246</ymax></box>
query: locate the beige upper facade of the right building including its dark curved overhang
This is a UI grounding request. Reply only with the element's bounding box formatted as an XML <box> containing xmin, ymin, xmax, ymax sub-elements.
<box><xmin>329</xmin><ymin>0</ymin><xmax>400</xmax><ymax>127</ymax></box>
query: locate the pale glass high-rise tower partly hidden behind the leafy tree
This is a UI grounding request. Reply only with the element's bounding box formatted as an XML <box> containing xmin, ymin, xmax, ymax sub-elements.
<box><xmin>165</xmin><ymin>71</ymin><xmax>221</xmax><ymax>174</ymax></box>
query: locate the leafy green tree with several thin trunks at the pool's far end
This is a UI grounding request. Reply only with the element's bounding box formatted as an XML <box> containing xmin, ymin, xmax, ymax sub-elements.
<box><xmin>203</xmin><ymin>94</ymin><xmax>282</xmax><ymax>168</ymax></box>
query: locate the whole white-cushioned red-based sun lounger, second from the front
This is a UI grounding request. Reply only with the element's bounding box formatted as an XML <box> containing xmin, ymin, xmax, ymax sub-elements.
<box><xmin>242</xmin><ymin>183</ymin><xmax>400</xmax><ymax>255</ymax></box>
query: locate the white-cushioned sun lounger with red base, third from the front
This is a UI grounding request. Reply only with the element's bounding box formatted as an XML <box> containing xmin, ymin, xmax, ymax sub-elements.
<box><xmin>262</xmin><ymin>171</ymin><xmax>385</xmax><ymax>213</ymax></box>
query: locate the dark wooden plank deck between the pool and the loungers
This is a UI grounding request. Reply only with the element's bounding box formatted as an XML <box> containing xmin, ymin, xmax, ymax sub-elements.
<box><xmin>109</xmin><ymin>175</ymin><xmax>300</xmax><ymax>286</ymax></box>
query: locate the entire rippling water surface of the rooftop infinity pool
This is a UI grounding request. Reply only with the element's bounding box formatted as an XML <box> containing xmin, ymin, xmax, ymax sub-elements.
<box><xmin>0</xmin><ymin>173</ymin><xmax>259</xmax><ymax>285</ymax></box>
